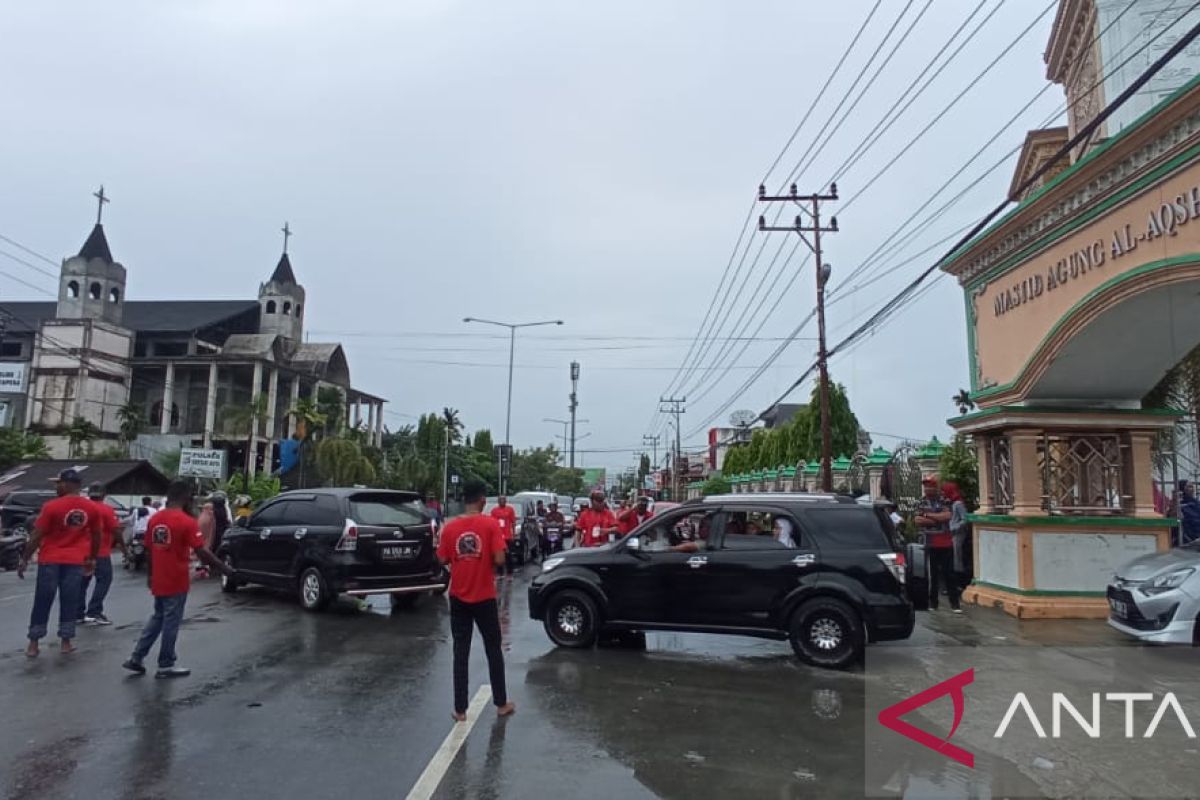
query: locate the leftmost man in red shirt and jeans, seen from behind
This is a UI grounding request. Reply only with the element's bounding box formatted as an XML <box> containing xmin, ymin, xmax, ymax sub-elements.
<box><xmin>17</xmin><ymin>469</ymin><xmax>100</xmax><ymax>658</ymax></box>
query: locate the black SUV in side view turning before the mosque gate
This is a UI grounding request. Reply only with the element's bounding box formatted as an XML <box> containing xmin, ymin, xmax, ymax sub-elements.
<box><xmin>529</xmin><ymin>494</ymin><xmax>913</xmax><ymax>668</ymax></box>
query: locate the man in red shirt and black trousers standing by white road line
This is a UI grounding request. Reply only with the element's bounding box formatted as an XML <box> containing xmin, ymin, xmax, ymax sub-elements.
<box><xmin>438</xmin><ymin>481</ymin><xmax>516</xmax><ymax>722</ymax></box>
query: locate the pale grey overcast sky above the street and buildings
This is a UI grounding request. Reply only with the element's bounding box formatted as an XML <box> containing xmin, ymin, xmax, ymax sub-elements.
<box><xmin>0</xmin><ymin>0</ymin><xmax>1062</xmax><ymax>467</ymax></box>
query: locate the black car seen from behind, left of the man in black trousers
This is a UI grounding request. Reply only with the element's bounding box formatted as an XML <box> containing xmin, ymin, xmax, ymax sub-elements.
<box><xmin>218</xmin><ymin>488</ymin><xmax>449</xmax><ymax>610</ymax></box>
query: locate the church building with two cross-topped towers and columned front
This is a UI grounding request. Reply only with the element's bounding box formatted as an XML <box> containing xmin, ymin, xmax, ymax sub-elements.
<box><xmin>0</xmin><ymin>200</ymin><xmax>384</xmax><ymax>474</ymax></box>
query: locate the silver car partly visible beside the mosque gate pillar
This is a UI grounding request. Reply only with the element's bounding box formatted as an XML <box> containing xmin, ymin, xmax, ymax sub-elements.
<box><xmin>1106</xmin><ymin>542</ymin><xmax>1200</xmax><ymax>644</ymax></box>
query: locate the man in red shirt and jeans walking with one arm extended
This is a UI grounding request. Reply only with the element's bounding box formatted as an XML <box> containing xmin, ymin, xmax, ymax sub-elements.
<box><xmin>121</xmin><ymin>481</ymin><xmax>234</xmax><ymax>678</ymax></box>
